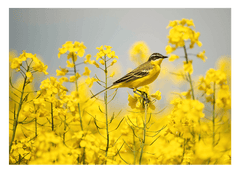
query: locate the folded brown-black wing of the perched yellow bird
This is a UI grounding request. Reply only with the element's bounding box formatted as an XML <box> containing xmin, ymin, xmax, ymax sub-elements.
<box><xmin>113</xmin><ymin>62</ymin><xmax>153</xmax><ymax>85</ymax></box>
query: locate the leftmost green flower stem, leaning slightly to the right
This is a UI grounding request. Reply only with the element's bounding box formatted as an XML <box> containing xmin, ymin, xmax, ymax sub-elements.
<box><xmin>8</xmin><ymin>72</ymin><xmax>29</xmax><ymax>153</ymax></box>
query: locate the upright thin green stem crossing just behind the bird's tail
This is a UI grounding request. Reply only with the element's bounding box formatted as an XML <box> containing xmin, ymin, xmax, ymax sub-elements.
<box><xmin>104</xmin><ymin>55</ymin><xmax>109</xmax><ymax>157</ymax></box>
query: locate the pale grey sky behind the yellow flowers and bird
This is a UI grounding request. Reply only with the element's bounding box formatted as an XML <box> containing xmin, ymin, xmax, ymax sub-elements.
<box><xmin>8</xmin><ymin>7</ymin><xmax>232</xmax><ymax>112</ymax></box>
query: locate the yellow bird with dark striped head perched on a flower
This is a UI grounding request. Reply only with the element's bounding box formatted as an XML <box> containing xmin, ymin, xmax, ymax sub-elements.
<box><xmin>91</xmin><ymin>53</ymin><xmax>167</xmax><ymax>98</ymax></box>
